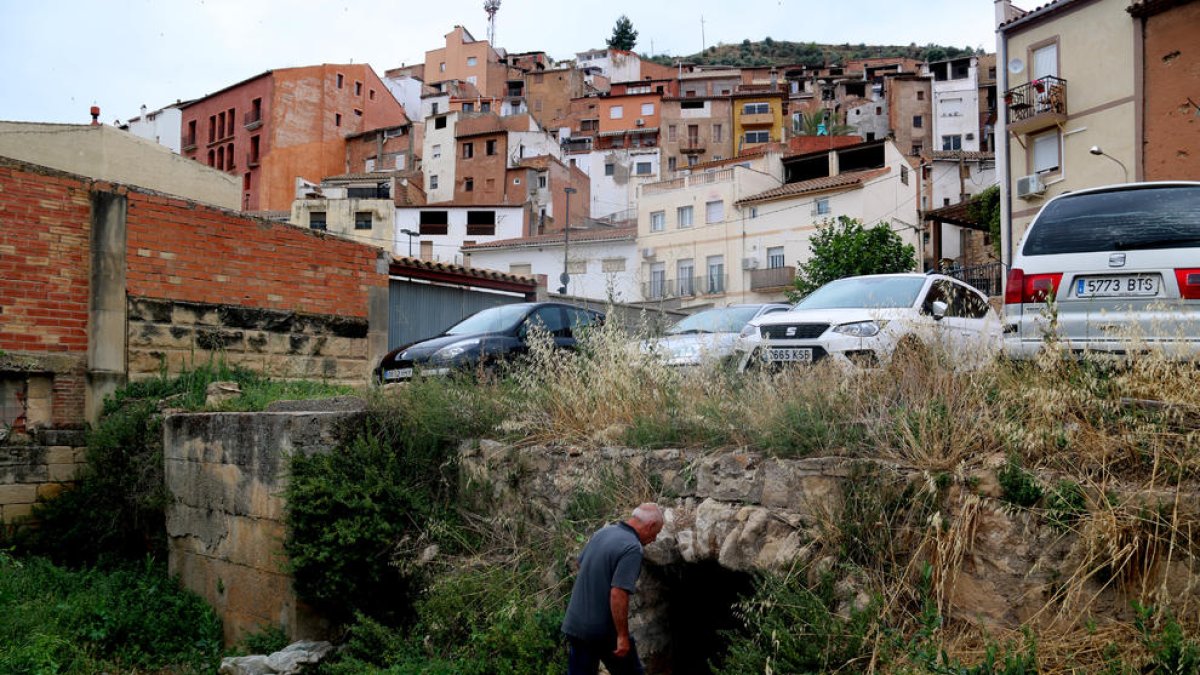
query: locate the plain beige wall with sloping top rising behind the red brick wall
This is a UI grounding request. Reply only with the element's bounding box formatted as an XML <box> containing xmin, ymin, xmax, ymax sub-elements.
<box><xmin>0</xmin><ymin>121</ymin><xmax>241</xmax><ymax>209</ymax></box>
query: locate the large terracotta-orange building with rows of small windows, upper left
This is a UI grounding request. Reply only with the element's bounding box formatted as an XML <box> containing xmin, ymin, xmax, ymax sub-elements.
<box><xmin>181</xmin><ymin>64</ymin><xmax>408</xmax><ymax>211</ymax></box>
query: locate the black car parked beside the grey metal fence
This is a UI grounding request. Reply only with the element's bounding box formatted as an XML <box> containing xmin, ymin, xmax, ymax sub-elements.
<box><xmin>374</xmin><ymin>303</ymin><xmax>604</xmax><ymax>383</ymax></box>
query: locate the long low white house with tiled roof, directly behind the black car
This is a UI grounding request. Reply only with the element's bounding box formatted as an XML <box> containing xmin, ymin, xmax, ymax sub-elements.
<box><xmin>464</xmin><ymin>227</ymin><xmax>641</xmax><ymax>303</ymax></box>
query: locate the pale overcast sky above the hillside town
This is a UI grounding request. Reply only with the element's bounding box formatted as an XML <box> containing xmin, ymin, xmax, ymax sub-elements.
<box><xmin>0</xmin><ymin>0</ymin><xmax>995</xmax><ymax>124</ymax></box>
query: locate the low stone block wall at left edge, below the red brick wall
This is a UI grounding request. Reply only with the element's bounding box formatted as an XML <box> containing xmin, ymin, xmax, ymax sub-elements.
<box><xmin>0</xmin><ymin>429</ymin><xmax>85</xmax><ymax>525</ymax></box>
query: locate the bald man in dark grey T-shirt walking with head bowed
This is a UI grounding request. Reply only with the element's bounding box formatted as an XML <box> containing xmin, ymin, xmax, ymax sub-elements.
<box><xmin>563</xmin><ymin>503</ymin><xmax>662</xmax><ymax>675</ymax></box>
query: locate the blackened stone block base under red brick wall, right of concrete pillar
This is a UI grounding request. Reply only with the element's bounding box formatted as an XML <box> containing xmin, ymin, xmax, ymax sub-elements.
<box><xmin>127</xmin><ymin>295</ymin><xmax>372</xmax><ymax>384</ymax></box>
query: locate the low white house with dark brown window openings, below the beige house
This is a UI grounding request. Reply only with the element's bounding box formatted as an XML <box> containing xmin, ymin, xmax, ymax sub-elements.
<box><xmin>392</xmin><ymin>204</ymin><xmax>526</xmax><ymax>265</ymax></box>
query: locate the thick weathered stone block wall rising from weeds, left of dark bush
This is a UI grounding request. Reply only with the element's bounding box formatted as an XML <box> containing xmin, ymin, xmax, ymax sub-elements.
<box><xmin>163</xmin><ymin>403</ymin><xmax>358</xmax><ymax>643</ymax></box>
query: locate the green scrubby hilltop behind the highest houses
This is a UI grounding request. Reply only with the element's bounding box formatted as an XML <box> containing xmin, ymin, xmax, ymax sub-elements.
<box><xmin>642</xmin><ymin>37</ymin><xmax>983</xmax><ymax>66</ymax></box>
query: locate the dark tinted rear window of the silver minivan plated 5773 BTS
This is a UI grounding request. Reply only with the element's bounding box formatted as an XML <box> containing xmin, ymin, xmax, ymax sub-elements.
<box><xmin>1021</xmin><ymin>186</ymin><xmax>1200</xmax><ymax>256</ymax></box>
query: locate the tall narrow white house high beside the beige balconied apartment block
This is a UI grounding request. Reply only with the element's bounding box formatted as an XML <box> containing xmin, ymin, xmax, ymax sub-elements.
<box><xmin>925</xmin><ymin>56</ymin><xmax>979</xmax><ymax>151</ymax></box>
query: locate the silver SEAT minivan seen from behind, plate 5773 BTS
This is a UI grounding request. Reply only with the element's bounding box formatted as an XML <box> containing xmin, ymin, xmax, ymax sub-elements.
<box><xmin>1004</xmin><ymin>181</ymin><xmax>1200</xmax><ymax>359</ymax></box>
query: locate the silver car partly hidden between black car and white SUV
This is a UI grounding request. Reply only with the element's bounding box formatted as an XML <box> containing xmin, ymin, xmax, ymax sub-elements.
<box><xmin>638</xmin><ymin>303</ymin><xmax>792</xmax><ymax>366</ymax></box>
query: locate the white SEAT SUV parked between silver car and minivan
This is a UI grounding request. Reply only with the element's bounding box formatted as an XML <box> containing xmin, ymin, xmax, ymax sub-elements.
<box><xmin>738</xmin><ymin>274</ymin><xmax>1001</xmax><ymax>370</ymax></box>
